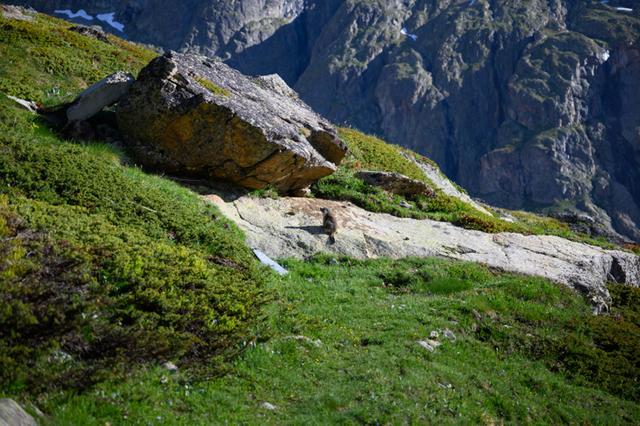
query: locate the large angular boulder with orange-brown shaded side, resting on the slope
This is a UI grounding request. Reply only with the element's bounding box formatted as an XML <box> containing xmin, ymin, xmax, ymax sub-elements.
<box><xmin>117</xmin><ymin>53</ymin><xmax>347</xmax><ymax>191</ymax></box>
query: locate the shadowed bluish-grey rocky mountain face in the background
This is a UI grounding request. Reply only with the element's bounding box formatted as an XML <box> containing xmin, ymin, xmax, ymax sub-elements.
<box><xmin>13</xmin><ymin>0</ymin><xmax>640</xmax><ymax>241</ymax></box>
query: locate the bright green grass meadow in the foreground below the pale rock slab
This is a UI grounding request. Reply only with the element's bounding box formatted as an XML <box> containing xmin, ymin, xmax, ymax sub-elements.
<box><xmin>47</xmin><ymin>257</ymin><xmax>640</xmax><ymax>425</ymax></box>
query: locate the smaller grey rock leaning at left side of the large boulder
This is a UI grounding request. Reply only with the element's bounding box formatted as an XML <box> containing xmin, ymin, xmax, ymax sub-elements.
<box><xmin>67</xmin><ymin>71</ymin><xmax>134</xmax><ymax>122</ymax></box>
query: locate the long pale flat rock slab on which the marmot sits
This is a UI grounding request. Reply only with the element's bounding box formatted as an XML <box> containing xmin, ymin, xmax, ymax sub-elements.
<box><xmin>214</xmin><ymin>197</ymin><xmax>640</xmax><ymax>312</ymax></box>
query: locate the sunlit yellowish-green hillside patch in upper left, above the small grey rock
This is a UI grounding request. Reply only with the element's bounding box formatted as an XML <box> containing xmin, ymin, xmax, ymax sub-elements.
<box><xmin>0</xmin><ymin>11</ymin><xmax>156</xmax><ymax>105</ymax></box>
